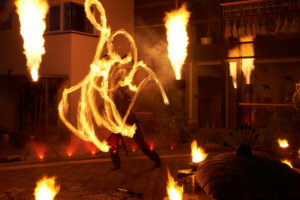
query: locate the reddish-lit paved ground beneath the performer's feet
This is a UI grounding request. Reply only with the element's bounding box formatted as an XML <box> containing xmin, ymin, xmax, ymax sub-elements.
<box><xmin>0</xmin><ymin>152</ymin><xmax>211</xmax><ymax>200</ymax></box>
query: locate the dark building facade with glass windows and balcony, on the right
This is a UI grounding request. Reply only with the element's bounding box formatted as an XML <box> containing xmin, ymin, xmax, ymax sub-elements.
<box><xmin>135</xmin><ymin>0</ymin><xmax>300</xmax><ymax>128</ymax></box>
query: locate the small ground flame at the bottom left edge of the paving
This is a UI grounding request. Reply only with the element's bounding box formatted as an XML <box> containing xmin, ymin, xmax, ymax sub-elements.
<box><xmin>34</xmin><ymin>176</ymin><xmax>60</xmax><ymax>200</ymax></box>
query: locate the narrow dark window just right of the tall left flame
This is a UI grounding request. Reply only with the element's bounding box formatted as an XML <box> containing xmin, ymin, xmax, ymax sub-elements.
<box><xmin>47</xmin><ymin>5</ymin><xmax>60</xmax><ymax>31</ymax></box>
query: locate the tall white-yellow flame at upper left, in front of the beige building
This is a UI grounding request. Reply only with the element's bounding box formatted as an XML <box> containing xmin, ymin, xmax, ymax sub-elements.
<box><xmin>16</xmin><ymin>0</ymin><xmax>49</xmax><ymax>81</ymax></box>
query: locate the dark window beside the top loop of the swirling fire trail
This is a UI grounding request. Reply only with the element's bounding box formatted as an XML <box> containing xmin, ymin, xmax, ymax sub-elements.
<box><xmin>64</xmin><ymin>2</ymin><xmax>93</xmax><ymax>34</ymax></box>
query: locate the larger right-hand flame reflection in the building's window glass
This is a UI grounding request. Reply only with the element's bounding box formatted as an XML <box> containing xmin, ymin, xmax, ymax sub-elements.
<box><xmin>240</xmin><ymin>36</ymin><xmax>254</xmax><ymax>84</ymax></box>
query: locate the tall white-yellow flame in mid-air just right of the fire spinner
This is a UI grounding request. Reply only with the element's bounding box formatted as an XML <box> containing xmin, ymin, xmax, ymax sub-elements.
<box><xmin>164</xmin><ymin>4</ymin><xmax>190</xmax><ymax>80</ymax></box>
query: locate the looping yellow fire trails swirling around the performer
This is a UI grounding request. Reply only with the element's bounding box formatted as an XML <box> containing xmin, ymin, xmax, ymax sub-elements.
<box><xmin>58</xmin><ymin>0</ymin><xmax>169</xmax><ymax>152</ymax></box>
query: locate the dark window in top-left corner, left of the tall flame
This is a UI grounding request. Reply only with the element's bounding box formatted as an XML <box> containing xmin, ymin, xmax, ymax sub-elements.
<box><xmin>0</xmin><ymin>0</ymin><xmax>12</xmax><ymax>28</ymax></box>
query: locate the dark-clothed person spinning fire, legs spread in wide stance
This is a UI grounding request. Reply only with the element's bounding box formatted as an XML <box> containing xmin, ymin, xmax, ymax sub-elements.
<box><xmin>107</xmin><ymin>68</ymin><xmax>161</xmax><ymax>170</ymax></box>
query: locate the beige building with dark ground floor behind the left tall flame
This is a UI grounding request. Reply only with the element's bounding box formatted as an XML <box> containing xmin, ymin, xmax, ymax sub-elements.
<box><xmin>0</xmin><ymin>0</ymin><xmax>134</xmax><ymax>141</ymax></box>
